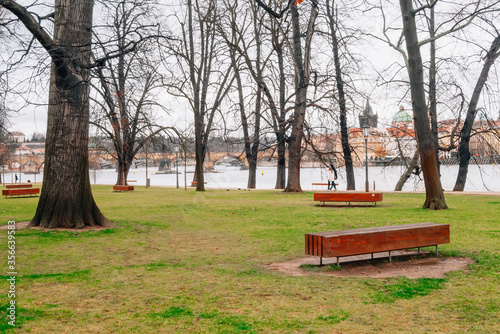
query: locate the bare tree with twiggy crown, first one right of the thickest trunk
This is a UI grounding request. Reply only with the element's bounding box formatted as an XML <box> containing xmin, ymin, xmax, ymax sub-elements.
<box><xmin>92</xmin><ymin>0</ymin><xmax>165</xmax><ymax>185</ymax></box>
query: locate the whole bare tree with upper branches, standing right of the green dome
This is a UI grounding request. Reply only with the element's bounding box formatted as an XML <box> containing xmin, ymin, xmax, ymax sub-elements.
<box><xmin>374</xmin><ymin>0</ymin><xmax>498</xmax><ymax>205</ymax></box>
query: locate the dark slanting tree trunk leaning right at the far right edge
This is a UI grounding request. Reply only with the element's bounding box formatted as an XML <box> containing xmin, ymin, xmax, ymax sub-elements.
<box><xmin>453</xmin><ymin>36</ymin><xmax>500</xmax><ymax>191</ymax></box>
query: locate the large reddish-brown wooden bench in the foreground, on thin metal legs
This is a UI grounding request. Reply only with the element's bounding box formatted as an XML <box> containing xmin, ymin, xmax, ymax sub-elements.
<box><xmin>305</xmin><ymin>223</ymin><xmax>450</xmax><ymax>265</ymax></box>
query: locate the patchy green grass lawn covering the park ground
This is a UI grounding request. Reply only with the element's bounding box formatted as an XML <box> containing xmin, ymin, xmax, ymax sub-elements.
<box><xmin>0</xmin><ymin>186</ymin><xmax>500</xmax><ymax>333</ymax></box>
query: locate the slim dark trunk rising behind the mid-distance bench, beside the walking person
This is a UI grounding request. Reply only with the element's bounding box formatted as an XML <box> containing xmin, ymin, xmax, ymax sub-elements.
<box><xmin>326</xmin><ymin>1</ymin><xmax>356</xmax><ymax>190</ymax></box>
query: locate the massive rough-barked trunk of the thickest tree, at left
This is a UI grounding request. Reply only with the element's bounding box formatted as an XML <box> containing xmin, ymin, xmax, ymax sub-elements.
<box><xmin>30</xmin><ymin>0</ymin><xmax>109</xmax><ymax>228</ymax></box>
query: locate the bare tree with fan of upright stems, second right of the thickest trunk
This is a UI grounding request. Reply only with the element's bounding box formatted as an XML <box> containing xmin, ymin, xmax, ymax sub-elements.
<box><xmin>167</xmin><ymin>0</ymin><xmax>234</xmax><ymax>191</ymax></box>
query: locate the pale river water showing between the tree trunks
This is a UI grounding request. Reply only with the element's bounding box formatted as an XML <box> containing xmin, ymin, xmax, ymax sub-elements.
<box><xmin>5</xmin><ymin>165</ymin><xmax>500</xmax><ymax>192</ymax></box>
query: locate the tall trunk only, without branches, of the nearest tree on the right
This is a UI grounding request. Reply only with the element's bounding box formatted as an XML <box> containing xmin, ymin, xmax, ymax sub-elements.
<box><xmin>399</xmin><ymin>0</ymin><xmax>448</xmax><ymax>210</ymax></box>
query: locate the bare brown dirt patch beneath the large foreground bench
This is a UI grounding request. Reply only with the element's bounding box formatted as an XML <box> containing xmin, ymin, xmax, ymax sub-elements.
<box><xmin>264</xmin><ymin>251</ymin><xmax>474</xmax><ymax>278</ymax></box>
